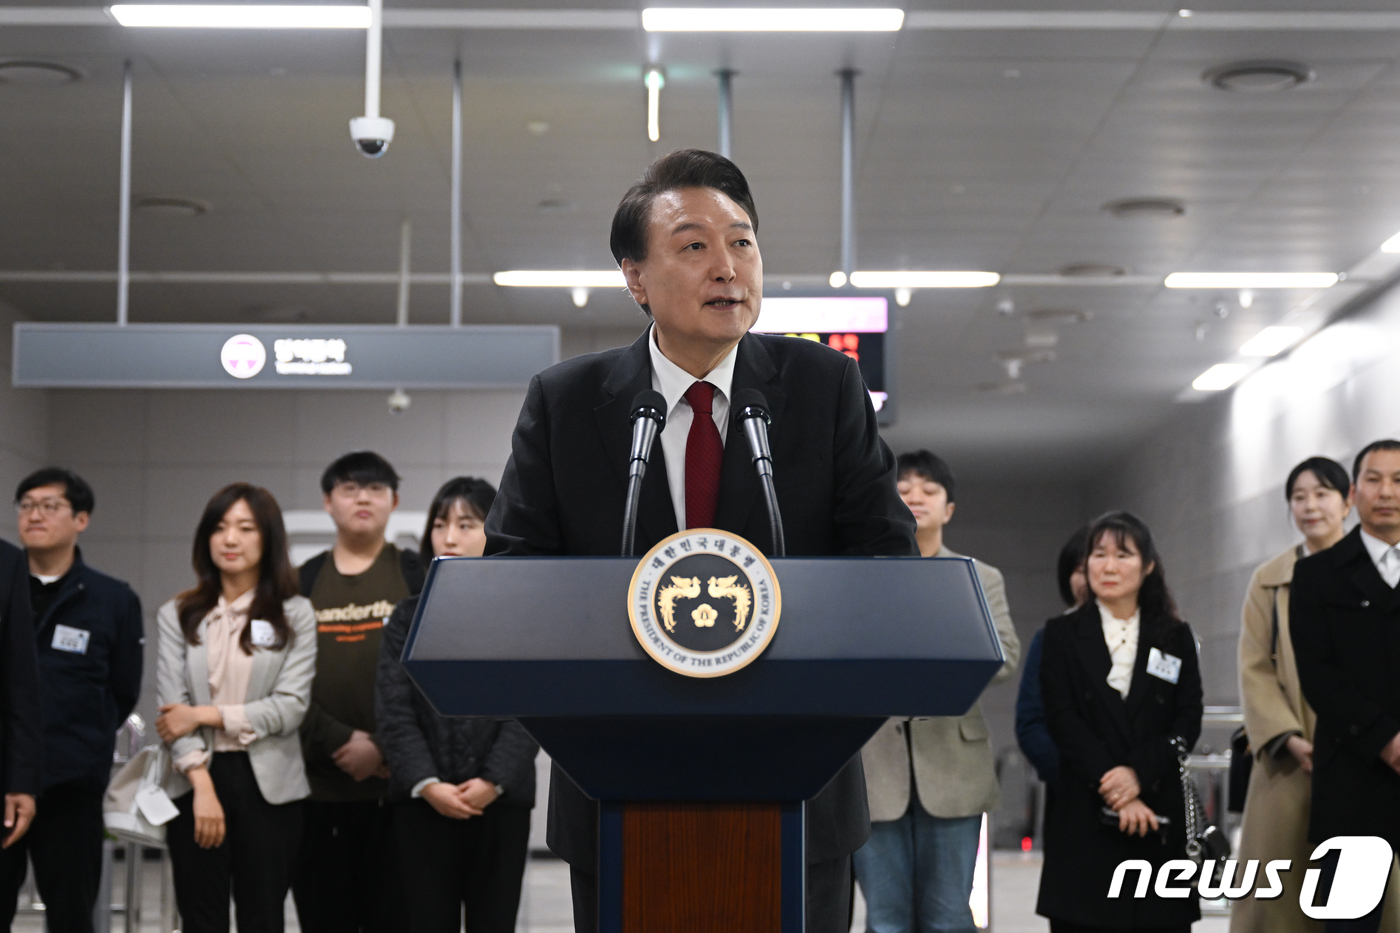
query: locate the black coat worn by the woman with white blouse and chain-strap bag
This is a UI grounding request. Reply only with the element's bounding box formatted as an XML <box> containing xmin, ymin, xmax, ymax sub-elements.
<box><xmin>1036</xmin><ymin>600</ymin><xmax>1204</xmax><ymax>930</ymax></box>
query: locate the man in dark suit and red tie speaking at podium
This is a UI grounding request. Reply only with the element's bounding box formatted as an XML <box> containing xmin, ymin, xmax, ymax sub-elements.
<box><xmin>486</xmin><ymin>150</ymin><xmax>918</xmax><ymax>933</ymax></box>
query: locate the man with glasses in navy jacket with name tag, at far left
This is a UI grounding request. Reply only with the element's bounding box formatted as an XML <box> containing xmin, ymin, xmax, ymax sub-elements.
<box><xmin>0</xmin><ymin>467</ymin><xmax>146</xmax><ymax>933</ymax></box>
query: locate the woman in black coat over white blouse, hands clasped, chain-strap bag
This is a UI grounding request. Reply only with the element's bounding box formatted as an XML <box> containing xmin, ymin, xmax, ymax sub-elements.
<box><xmin>1036</xmin><ymin>511</ymin><xmax>1203</xmax><ymax>933</ymax></box>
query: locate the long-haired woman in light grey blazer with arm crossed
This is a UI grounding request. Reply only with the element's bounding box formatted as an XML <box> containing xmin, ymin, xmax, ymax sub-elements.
<box><xmin>155</xmin><ymin>483</ymin><xmax>316</xmax><ymax>933</ymax></box>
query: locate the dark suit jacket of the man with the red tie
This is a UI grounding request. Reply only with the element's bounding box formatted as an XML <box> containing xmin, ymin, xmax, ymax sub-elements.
<box><xmin>486</xmin><ymin>329</ymin><xmax>918</xmax><ymax>871</ymax></box>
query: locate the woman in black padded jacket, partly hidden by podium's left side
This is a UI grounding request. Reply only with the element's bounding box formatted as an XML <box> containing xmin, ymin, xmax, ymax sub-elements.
<box><xmin>374</xmin><ymin>476</ymin><xmax>539</xmax><ymax>933</ymax></box>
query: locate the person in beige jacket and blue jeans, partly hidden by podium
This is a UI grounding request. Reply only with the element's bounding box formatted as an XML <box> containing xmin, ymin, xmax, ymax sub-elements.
<box><xmin>855</xmin><ymin>450</ymin><xmax>1021</xmax><ymax>933</ymax></box>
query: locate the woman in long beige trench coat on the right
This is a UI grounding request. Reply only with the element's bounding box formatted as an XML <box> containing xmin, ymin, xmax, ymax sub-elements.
<box><xmin>1229</xmin><ymin>457</ymin><xmax>1397</xmax><ymax>933</ymax></box>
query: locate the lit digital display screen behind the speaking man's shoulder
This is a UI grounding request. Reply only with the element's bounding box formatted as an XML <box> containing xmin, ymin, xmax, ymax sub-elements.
<box><xmin>750</xmin><ymin>294</ymin><xmax>893</xmax><ymax>424</ymax></box>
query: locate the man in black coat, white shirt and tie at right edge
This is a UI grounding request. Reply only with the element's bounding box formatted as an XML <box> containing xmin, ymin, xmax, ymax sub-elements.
<box><xmin>1288</xmin><ymin>440</ymin><xmax>1400</xmax><ymax>933</ymax></box>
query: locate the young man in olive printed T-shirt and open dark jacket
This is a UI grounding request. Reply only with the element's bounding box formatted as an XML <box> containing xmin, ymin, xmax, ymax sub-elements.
<box><xmin>293</xmin><ymin>451</ymin><xmax>423</xmax><ymax>933</ymax></box>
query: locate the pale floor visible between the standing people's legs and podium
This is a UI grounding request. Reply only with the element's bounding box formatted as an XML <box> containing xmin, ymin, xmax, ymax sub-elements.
<box><xmin>11</xmin><ymin>852</ymin><xmax>1228</xmax><ymax>933</ymax></box>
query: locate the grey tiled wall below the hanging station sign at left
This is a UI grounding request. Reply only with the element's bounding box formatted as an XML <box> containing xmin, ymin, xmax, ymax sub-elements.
<box><xmin>48</xmin><ymin>389</ymin><xmax>524</xmax><ymax>714</ymax></box>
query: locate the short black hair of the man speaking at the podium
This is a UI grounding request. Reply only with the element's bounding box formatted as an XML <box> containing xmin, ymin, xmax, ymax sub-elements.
<box><xmin>608</xmin><ymin>148</ymin><xmax>759</xmax><ymax>277</ymax></box>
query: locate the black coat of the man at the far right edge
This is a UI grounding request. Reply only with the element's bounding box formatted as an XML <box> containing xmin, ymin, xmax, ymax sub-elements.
<box><xmin>1288</xmin><ymin>528</ymin><xmax>1400</xmax><ymax>848</ymax></box>
